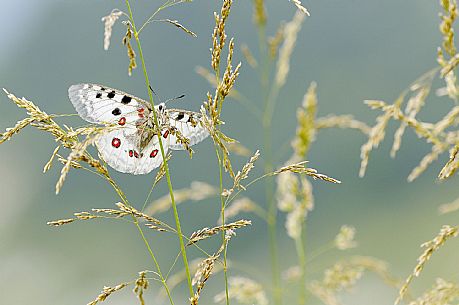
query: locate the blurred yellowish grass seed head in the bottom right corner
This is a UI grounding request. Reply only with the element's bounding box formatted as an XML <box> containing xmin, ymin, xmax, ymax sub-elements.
<box><xmin>409</xmin><ymin>278</ymin><xmax>459</xmax><ymax>305</ymax></box>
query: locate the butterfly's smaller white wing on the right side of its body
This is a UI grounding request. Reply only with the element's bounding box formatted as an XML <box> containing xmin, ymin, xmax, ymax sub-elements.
<box><xmin>167</xmin><ymin>109</ymin><xmax>209</xmax><ymax>150</ymax></box>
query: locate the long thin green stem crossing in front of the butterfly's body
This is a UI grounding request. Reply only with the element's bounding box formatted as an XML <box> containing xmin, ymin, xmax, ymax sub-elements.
<box><xmin>125</xmin><ymin>0</ymin><xmax>194</xmax><ymax>298</ymax></box>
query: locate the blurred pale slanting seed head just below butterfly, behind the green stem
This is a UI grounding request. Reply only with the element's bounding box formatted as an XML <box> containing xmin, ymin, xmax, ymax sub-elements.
<box><xmin>145</xmin><ymin>181</ymin><xmax>218</xmax><ymax>215</ymax></box>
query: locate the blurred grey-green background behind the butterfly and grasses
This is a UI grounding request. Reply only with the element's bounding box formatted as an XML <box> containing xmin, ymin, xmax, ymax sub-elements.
<box><xmin>0</xmin><ymin>0</ymin><xmax>459</xmax><ymax>305</ymax></box>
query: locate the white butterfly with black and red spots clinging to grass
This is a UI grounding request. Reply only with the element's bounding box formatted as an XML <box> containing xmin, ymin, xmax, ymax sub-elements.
<box><xmin>69</xmin><ymin>84</ymin><xmax>209</xmax><ymax>175</ymax></box>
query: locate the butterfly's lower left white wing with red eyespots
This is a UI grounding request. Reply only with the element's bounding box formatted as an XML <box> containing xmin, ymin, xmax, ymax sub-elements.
<box><xmin>96</xmin><ymin>129</ymin><xmax>170</xmax><ymax>175</ymax></box>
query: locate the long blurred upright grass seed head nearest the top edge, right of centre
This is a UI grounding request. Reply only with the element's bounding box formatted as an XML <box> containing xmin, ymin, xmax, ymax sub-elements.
<box><xmin>274</xmin><ymin>11</ymin><xmax>304</xmax><ymax>88</ymax></box>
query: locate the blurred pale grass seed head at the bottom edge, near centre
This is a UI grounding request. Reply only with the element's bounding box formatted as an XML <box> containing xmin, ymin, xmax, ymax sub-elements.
<box><xmin>214</xmin><ymin>276</ymin><xmax>268</xmax><ymax>305</ymax></box>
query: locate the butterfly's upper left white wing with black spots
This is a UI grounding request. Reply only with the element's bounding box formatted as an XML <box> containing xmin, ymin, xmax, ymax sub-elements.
<box><xmin>69</xmin><ymin>84</ymin><xmax>147</xmax><ymax>126</ymax></box>
